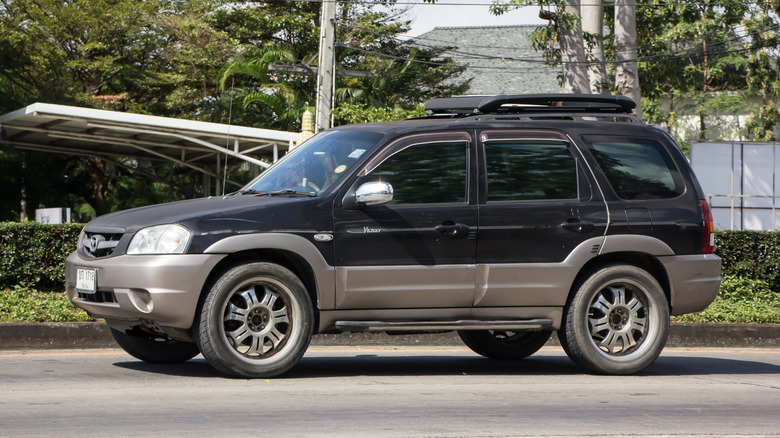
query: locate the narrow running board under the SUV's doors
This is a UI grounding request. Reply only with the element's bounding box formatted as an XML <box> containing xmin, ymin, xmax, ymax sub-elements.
<box><xmin>336</xmin><ymin>319</ymin><xmax>553</xmax><ymax>332</ymax></box>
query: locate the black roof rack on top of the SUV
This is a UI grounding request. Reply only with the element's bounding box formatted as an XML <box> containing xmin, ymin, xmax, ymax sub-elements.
<box><xmin>424</xmin><ymin>94</ymin><xmax>636</xmax><ymax>115</ymax></box>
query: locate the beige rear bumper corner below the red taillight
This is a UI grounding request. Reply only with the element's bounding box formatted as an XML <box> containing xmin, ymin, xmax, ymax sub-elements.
<box><xmin>658</xmin><ymin>254</ymin><xmax>721</xmax><ymax>315</ymax></box>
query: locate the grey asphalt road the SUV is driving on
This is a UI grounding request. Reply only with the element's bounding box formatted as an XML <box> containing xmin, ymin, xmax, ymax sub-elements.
<box><xmin>0</xmin><ymin>347</ymin><xmax>780</xmax><ymax>437</ymax></box>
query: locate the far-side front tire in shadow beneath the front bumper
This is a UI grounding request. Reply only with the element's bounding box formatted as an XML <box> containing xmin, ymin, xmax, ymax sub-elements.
<box><xmin>111</xmin><ymin>328</ymin><xmax>200</xmax><ymax>363</ymax></box>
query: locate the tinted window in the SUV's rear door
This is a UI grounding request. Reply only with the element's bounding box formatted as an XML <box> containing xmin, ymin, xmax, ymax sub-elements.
<box><xmin>485</xmin><ymin>141</ymin><xmax>577</xmax><ymax>201</ymax></box>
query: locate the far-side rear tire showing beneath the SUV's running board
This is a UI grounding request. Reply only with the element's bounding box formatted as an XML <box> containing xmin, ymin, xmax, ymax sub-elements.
<box><xmin>458</xmin><ymin>330</ymin><xmax>552</xmax><ymax>360</ymax></box>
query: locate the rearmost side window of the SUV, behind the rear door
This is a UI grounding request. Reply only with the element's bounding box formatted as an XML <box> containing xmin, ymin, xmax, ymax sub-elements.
<box><xmin>583</xmin><ymin>136</ymin><xmax>685</xmax><ymax>200</ymax></box>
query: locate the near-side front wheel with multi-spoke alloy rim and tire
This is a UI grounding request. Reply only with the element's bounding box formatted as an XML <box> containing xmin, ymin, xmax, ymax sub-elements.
<box><xmin>196</xmin><ymin>263</ymin><xmax>314</xmax><ymax>378</ymax></box>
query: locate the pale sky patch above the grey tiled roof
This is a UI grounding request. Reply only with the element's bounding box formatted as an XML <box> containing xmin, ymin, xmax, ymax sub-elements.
<box><xmin>398</xmin><ymin>0</ymin><xmax>547</xmax><ymax>36</ymax></box>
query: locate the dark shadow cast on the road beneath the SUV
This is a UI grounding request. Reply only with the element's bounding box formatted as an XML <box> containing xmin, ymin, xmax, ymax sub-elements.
<box><xmin>114</xmin><ymin>353</ymin><xmax>780</xmax><ymax>379</ymax></box>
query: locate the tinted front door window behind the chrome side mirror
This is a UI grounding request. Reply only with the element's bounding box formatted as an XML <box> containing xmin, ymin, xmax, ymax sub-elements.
<box><xmin>366</xmin><ymin>142</ymin><xmax>468</xmax><ymax>204</ymax></box>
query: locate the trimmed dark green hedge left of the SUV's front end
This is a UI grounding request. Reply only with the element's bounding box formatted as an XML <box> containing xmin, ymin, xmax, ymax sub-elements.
<box><xmin>0</xmin><ymin>222</ymin><xmax>84</xmax><ymax>291</ymax></box>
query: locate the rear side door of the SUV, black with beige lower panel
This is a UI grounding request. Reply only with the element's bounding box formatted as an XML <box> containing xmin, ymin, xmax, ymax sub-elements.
<box><xmin>474</xmin><ymin>130</ymin><xmax>607</xmax><ymax>307</ymax></box>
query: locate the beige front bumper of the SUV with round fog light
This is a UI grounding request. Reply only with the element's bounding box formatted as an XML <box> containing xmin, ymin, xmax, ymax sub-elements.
<box><xmin>65</xmin><ymin>252</ymin><xmax>225</xmax><ymax>329</ymax></box>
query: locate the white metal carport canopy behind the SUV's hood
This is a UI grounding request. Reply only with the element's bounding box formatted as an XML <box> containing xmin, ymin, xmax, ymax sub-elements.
<box><xmin>0</xmin><ymin>103</ymin><xmax>299</xmax><ymax>192</ymax></box>
